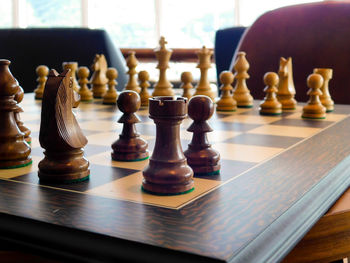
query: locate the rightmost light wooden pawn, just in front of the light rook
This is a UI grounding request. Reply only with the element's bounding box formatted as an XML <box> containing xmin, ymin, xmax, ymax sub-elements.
<box><xmin>302</xmin><ymin>73</ymin><xmax>326</xmax><ymax>119</ymax></box>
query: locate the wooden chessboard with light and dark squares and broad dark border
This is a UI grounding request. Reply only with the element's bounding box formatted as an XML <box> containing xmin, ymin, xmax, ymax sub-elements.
<box><xmin>0</xmin><ymin>94</ymin><xmax>350</xmax><ymax>262</ymax></box>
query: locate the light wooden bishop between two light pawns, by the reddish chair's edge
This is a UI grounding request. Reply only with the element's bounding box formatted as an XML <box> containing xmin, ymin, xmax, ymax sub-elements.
<box><xmin>233</xmin><ymin>51</ymin><xmax>253</xmax><ymax>108</ymax></box>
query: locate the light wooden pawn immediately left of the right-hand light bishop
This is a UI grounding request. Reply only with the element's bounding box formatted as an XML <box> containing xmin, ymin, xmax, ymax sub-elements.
<box><xmin>216</xmin><ymin>71</ymin><xmax>237</xmax><ymax>111</ymax></box>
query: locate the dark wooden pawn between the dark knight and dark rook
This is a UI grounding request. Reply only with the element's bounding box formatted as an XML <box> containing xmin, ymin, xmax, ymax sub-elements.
<box><xmin>112</xmin><ymin>90</ymin><xmax>148</xmax><ymax>162</ymax></box>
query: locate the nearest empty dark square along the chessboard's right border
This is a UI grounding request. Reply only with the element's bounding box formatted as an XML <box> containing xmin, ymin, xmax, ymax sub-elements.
<box><xmin>224</xmin><ymin>133</ymin><xmax>303</xmax><ymax>148</ymax></box>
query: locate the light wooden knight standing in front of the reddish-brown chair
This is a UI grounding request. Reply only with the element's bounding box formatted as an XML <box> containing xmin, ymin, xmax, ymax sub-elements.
<box><xmin>277</xmin><ymin>57</ymin><xmax>297</xmax><ymax>110</ymax></box>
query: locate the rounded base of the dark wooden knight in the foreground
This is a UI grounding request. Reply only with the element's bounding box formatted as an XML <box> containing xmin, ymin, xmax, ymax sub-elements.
<box><xmin>38</xmin><ymin>149</ymin><xmax>90</xmax><ymax>183</ymax></box>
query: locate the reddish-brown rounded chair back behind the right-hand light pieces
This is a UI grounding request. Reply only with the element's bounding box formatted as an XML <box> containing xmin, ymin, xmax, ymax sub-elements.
<box><xmin>230</xmin><ymin>1</ymin><xmax>350</xmax><ymax>104</ymax></box>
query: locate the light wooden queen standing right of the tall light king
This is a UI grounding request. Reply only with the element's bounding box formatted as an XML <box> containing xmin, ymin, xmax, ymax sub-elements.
<box><xmin>193</xmin><ymin>46</ymin><xmax>215</xmax><ymax>101</ymax></box>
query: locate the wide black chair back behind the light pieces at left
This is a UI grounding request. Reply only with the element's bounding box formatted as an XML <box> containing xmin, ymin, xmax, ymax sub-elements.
<box><xmin>0</xmin><ymin>28</ymin><xmax>127</xmax><ymax>92</ymax></box>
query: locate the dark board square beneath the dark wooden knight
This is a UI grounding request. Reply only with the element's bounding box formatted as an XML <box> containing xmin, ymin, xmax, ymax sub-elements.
<box><xmin>12</xmin><ymin>164</ymin><xmax>138</xmax><ymax>192</ymax></box>
